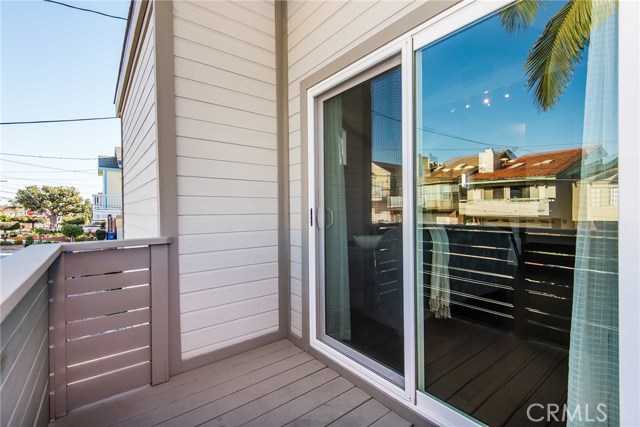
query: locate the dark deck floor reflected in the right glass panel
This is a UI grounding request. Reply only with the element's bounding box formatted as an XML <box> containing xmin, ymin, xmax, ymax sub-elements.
<box><xmin>425</xmin><ymin>319</ymin><xmax>568</xmax><ymax>427</ymax></box>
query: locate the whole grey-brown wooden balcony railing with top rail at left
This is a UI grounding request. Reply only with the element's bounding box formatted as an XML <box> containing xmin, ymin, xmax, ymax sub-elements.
<box><xmin>0</xmin><ymin>238</ymin><xmax>170</xmax><ymax>425</ymax></box>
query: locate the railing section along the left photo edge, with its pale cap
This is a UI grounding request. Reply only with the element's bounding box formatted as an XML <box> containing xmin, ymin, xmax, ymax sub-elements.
<box><xmin>0</xmin><ymin>245</ymin><xmax>60</xmax><ymax>426</ymax></box>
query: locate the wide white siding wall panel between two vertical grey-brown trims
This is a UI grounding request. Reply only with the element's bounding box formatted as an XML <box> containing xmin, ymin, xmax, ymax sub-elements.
<box><xmin>173</xmin><ymin>1</ymin><xmax>278</xmax><ymax>359</ymax></box>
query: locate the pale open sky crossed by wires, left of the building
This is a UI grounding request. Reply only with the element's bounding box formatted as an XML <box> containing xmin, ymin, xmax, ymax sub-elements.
<box><xmin>0</xmin><ymin>0</ymin><xmax>129</xmax><ymax>203</ymax></box>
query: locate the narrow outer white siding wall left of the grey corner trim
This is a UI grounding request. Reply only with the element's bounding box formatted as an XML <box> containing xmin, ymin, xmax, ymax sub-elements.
<box><xmin>122</xmin><ymin>5</ymin><xmax>159</xmax><ymax>239</ymax></box>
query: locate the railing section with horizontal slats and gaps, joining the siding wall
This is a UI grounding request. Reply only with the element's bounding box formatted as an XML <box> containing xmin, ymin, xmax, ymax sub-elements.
<box><xmin>49</xmin><ymin>239</ymin><xmax>169</xmax><ymax>418</ymax></box>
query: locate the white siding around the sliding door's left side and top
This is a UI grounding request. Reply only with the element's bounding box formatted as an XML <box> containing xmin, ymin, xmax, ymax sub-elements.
<box><xmin>288</xmin><ymin>0</ymin><xmax>420</xmax><ymax>336</ymax></box>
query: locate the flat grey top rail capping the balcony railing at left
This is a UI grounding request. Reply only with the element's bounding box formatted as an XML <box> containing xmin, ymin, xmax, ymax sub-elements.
<box><xmin>0</xmin><ymin>237</ymin><xmax>171</xmax><ymax>322</ymax></box>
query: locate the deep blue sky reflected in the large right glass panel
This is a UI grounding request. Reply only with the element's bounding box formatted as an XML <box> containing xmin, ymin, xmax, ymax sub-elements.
<box><xmin>417</xmin><ymin>2</ymin><xmax>587</xmax><ymax>166</ymax></box>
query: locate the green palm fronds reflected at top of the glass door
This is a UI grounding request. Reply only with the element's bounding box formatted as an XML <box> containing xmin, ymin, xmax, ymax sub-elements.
<box><xmin>499</xmin><ymin>0</ymin><xmax>618</xmax><ymax>111</ymax></box>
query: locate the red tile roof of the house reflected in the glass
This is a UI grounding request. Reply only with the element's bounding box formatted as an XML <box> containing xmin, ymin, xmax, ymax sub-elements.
<box><xmin>471</xmin><ymin>148</ymin><xmax>583</xmax><ymax>181</ymax></box>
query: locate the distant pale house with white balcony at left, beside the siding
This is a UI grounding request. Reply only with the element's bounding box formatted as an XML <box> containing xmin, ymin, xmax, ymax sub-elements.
<box><xmin>91</xmin><ymin>147</ymin><xmax>122</xmax><ymax>221</ymax></box>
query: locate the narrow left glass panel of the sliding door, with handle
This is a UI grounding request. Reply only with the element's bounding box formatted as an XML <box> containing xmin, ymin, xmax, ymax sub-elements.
<box><xmin>321</xmin><ymin>66</ymin><xmax>404</xmax><ymax>382</ymax></box>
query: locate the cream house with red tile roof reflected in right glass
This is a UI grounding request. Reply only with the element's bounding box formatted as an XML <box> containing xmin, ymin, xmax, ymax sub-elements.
<box><xmin>460</xmin><ymin>148</ymin><xmax>583</xmax><ymax>228</ymax></box>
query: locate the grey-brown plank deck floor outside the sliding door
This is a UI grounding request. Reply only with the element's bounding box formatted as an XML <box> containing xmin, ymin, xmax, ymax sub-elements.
<box><xmin>50</xmin><ymin>340</ymin><xmax>411</xmax><ymax>427</ymax></box>
